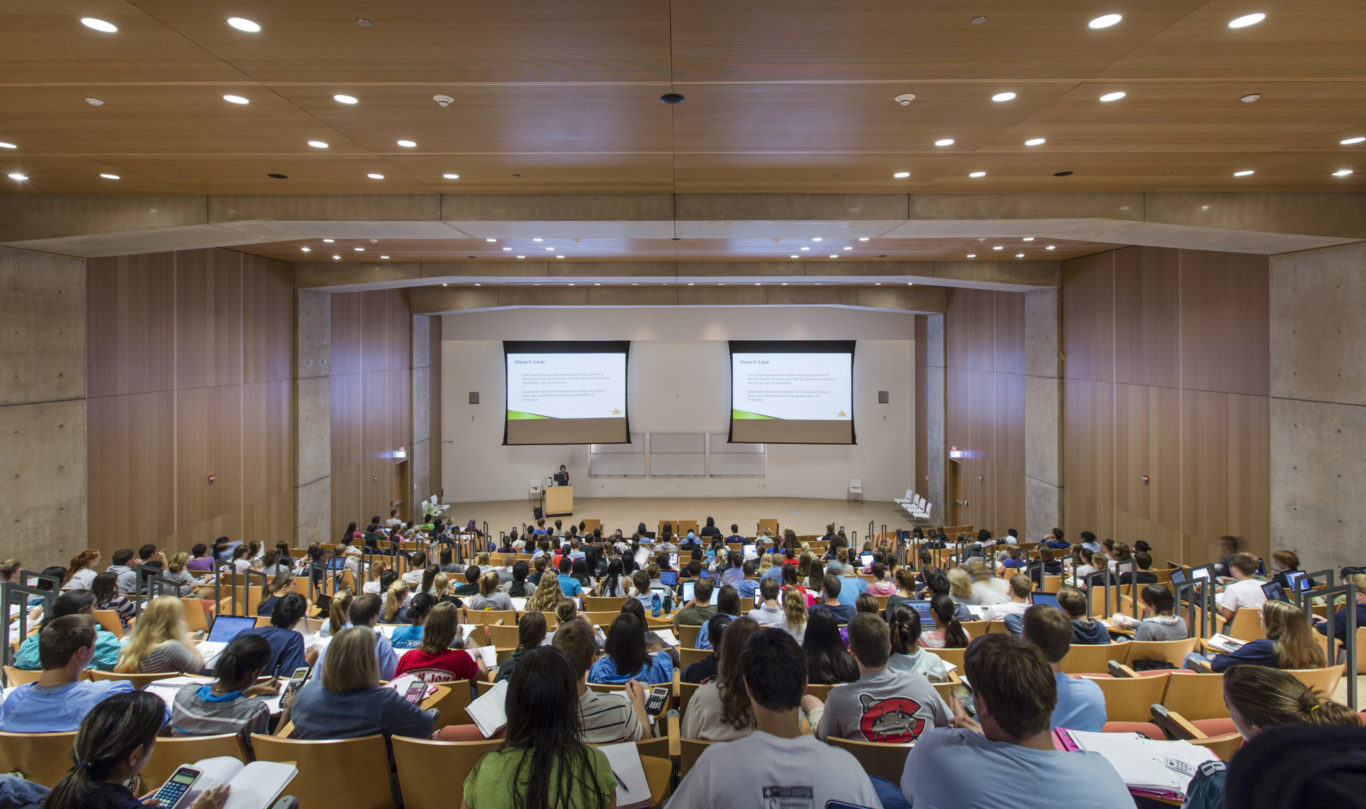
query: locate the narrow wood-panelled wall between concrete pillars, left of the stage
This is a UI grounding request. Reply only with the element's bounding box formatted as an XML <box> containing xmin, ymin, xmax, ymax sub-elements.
<box><xmin>331</xmin><ymin>290</ymin><xmax>409</xmax><ymax>537</ymax></box>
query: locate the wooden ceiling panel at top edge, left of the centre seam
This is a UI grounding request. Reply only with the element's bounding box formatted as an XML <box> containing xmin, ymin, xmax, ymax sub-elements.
<box><xmin>129</xmin><ymin>0</ymin><xmax>669</xmax><ymax>85</ymax></box>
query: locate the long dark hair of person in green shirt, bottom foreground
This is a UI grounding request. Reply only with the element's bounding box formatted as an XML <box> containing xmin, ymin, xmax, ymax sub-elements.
<box><xmin>474</xmin><ymin>646</ymin><xmax>612</xmax><ymax>809</ymax></box>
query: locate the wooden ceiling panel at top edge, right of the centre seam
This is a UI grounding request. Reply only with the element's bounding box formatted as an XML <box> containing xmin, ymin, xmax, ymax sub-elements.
<box><xmin>673</xmin><ymin>0</ymin><xmax>1205</xmax><ymax>81</ymax></box>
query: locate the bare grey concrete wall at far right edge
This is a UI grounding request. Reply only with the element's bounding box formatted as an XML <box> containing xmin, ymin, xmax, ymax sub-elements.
<box><xmin>1270</xmin><ymin>243</ymin><xmax>1366</xmax><ymax>570</ymax></box>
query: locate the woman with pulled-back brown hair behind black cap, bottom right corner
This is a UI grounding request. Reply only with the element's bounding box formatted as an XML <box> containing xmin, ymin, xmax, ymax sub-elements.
<box><xmin>1183</xmin><ymin>666</ymin><xmax>1361</xmax><ymax>809</ymax></box>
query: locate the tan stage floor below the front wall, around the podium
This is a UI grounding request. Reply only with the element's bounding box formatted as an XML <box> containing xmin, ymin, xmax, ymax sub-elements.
<box><xmin>447</xmin><ymin>497</ymin><xmax>911</xmax><ymax>540</ymax></box>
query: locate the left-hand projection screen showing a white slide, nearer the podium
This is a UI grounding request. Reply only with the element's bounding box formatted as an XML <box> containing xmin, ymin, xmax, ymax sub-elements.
<box><xmin>503</xmin><ymin>342</ymin><xmax>630</xmax><ymax>444</ymax></box>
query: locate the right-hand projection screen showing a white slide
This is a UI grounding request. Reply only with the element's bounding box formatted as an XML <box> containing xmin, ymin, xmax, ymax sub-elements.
<box><xmin>731</xmin><ymin>340</ymin><xmax>854</xmax><ymax>444</ymax></box>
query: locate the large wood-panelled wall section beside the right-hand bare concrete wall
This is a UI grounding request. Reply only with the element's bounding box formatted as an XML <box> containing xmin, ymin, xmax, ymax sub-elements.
<box><xmin>1063</xmin><ymin>247</ymin><xmax>1270</xmax><ymax>563</ymax></box>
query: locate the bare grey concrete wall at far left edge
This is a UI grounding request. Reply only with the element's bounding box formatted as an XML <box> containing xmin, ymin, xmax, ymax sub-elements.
<box><xmin>0</xmin><ymin>247</ymin><xmax>87</xmax><ymax>570</ymax></box>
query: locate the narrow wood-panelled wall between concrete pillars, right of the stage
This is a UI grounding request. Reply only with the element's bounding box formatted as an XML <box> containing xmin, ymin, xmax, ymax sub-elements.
<box><xmin>941</xmin><ymin>290</ymin><xmax>1025</xmax><ymax>534</ymax></box>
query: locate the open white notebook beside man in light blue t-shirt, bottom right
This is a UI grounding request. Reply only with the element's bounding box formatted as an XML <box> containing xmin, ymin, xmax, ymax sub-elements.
<box><xmin>1053</xmin><ymin>728</ymin><xmax>1218</xmax><ymax>801</ymax></box>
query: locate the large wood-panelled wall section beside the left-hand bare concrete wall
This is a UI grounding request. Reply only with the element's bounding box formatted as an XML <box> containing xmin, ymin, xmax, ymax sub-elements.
<box><xmin>86</xmin><ymin>250</ymin><xmax>294</xmax><ymax>558</ymax></box>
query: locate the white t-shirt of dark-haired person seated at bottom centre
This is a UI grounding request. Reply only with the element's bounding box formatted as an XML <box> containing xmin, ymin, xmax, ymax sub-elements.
<box><xmin>668</xmin><ymin>731</ymin><xmax>885</xmax><ymax>809</ymax></box>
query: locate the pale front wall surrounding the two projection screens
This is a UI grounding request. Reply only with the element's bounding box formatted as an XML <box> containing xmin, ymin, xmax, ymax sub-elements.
<box><xmin>441</xmin><ymin>309</ymin><xmax>915</xmax><ymax>502</ymax></box>
